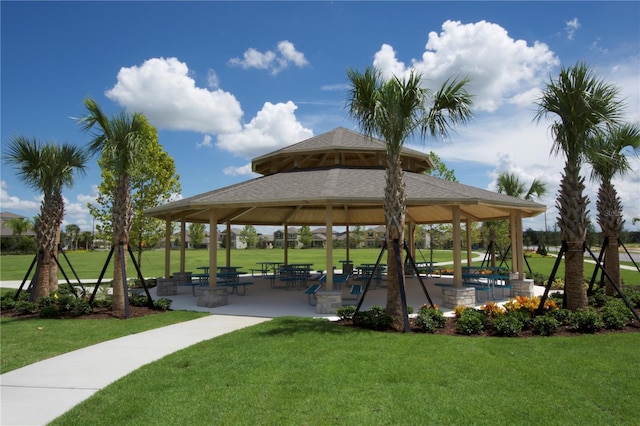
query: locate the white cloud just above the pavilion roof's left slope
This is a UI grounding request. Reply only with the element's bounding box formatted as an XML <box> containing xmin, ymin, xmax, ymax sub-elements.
<box><xmin>216</xmin><ymin>101</ymin><xmax>313</xmax><ymax>158</ymax></box>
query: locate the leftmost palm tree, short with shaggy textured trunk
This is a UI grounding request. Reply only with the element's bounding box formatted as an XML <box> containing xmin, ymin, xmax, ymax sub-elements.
<box><xmin>5</xmin><ymin>136</ymin><xmax>88</xmax><ymax>301</ymax></box>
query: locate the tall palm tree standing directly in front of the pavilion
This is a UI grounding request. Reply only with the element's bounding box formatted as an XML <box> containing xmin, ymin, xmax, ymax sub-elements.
<box><xmin>347</xmin><ymin>67</ymin><xmax>472</xmax><ymax>320</ymax></box>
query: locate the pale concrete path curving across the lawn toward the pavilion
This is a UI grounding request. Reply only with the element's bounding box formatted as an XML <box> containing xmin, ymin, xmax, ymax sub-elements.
<box><xmin>0</xmin><ymin>315</ymin><xmax>270</xmax><ymax>426</ymax></box>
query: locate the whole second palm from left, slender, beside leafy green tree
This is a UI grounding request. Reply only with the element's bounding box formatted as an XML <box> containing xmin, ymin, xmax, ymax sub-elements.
<box><xmin>80</xmin><ymin>99</ymin><xmax>145</xmax><ymax>310</ymax></box>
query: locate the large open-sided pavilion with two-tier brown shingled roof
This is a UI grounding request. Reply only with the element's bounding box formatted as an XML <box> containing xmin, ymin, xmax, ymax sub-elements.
<box><xmin>145</xmin><ymin>127</ymin><xmax>546</xmax><ymax>310</ymax></box>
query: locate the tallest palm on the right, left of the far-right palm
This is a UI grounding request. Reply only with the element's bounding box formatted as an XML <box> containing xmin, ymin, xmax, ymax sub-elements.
<box><xmin>536</xmin><ymin>63</ymin><xmax>622</xmax><ymax>310</ymax></box>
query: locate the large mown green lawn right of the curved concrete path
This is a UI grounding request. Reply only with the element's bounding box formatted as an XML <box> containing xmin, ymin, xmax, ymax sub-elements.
<box><xmin>51</xmin><ymin>317</ymin><xmax>640</xmax><ymax>425</ymax></box>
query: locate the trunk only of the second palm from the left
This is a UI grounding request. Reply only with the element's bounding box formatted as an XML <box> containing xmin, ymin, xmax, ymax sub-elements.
<box><xmin>112</xmin><ymin>174</ymin><xmax>131</xmax><ymax>311</ymax></box>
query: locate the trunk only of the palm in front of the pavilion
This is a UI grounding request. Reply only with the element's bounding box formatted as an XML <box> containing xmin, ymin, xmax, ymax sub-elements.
<box><xmin>384</xmin><ymin>155</ymin><xmax>406</xmax><ymax>319</ymax></box>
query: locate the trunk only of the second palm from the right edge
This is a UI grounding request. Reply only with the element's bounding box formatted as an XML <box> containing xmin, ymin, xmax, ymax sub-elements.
<box><xmin>557</xmin><ymin>162</ymin><xmax>588</xmax><ymax>311</ymax></box>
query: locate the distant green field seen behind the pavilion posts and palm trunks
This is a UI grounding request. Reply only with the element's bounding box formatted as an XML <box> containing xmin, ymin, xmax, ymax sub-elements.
<box><xmin>0</xmin><ymin>249</ymin><xmax>640</xmax><ymax>285</ymax></box>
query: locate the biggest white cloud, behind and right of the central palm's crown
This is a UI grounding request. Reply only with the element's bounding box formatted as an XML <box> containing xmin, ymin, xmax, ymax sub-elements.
<box><xmin>373</xmin><ymin>21</ymin><xmax>559</xmax><ymax>111</ymax></box>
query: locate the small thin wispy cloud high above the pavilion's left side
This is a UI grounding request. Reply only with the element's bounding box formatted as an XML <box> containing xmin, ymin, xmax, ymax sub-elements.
<box><xmin>228</xmin><ymin>40</ymin><xmax>309</xmax><ymax>75</ymax></box>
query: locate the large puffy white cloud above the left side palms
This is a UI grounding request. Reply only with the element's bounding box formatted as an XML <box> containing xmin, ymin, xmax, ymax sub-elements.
<box><xmin>105</xmin><ymin>58</ymin><xmax>242</xmax><ymax>133</ymax></box>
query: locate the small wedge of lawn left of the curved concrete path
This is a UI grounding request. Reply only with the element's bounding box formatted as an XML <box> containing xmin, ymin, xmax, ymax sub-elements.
<box><xmin>0</xmin><ymin>311</ymin><xmax>208</xmax><ymax>373</ymax></box>
